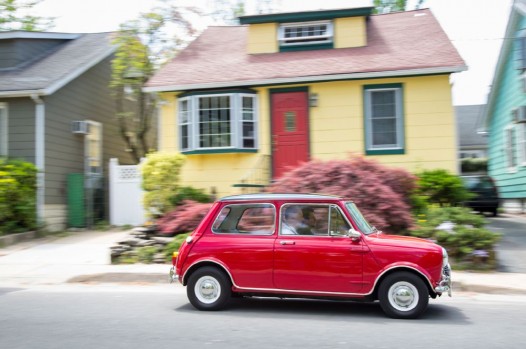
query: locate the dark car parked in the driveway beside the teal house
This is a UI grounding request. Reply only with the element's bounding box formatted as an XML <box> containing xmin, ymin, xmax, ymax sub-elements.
<box><xmin>461</xmin><ymin>175</ymin><xmax>499</xmax><ymax>217</ymax></box>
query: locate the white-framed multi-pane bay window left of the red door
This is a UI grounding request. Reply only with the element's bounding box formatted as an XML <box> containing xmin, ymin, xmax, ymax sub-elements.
<box><xmin>178</xmin><ymin>93</ymin><xmax>257</xmax><ymax>153</ymax></box>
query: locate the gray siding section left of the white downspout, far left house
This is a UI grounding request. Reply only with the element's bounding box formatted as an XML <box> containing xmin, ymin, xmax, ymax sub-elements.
<box><xmin>0</xmin><ymin>98</ymin><xmax>35</xmax><ymax>163</ymax></box>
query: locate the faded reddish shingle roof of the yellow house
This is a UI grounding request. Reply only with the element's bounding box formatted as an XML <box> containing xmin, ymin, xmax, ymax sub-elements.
<box><xmin>144</xmin><ymin>9</ymin><xmax>467</xmax><ymax>92</ymax></box>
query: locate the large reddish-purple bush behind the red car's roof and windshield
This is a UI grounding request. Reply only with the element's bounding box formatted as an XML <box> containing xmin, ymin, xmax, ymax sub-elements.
<box><xmin>268</xmin><ymin>157</ymin><xmax>415</xmax><ymax>233</ymax></box>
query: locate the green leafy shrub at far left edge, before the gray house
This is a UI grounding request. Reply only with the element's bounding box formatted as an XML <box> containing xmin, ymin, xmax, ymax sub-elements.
<box><xmin>0</xmin><ymin>158</ymin><xmax>37</xmax><ymax>235</ymax></box>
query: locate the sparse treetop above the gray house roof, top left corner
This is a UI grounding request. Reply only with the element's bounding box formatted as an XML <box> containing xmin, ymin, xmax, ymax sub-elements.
<box><xmin>0</xmin><ymin>0</ymin><xmax>53</xmax><ymax>31</ymax></box>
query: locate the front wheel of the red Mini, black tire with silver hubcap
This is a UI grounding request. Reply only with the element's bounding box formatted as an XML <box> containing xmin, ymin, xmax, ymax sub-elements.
<box><xmin>378</xmin><ymin>272</ymin><xmax>429</xmax><ymax>319</ymax></box>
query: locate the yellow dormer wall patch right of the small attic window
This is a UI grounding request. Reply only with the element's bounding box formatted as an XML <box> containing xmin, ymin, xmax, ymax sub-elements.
<box><xmin>334</xmin><ymin>17</ymin><xmax>367</xmax><ymax>48</ymax></box>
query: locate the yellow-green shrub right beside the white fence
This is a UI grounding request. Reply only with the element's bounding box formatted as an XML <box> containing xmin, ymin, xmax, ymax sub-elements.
<box><xmin>141</xmin><ymin>153</ymin><xmax>185</xmax><ymax>217</ymax></box>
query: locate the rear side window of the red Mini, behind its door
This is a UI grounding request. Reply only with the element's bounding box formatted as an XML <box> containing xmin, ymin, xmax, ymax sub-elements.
<box><xmin>212</xmin><ymin>204</ymin><xmax>276</xmax><ymax>235</ymax></box>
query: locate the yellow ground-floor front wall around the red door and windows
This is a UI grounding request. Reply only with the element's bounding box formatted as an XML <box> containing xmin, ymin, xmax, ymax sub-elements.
<box><xmin>159</xmin><ymin>75</ymin><xmax>457</xmax><ymax>196</ymax></box>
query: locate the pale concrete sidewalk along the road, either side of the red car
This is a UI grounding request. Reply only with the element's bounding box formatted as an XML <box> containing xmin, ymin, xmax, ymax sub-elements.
<box><xmin>0</xmin><ymin>231</ymin><xmax>526</xmax><ymax>294</ymax></box>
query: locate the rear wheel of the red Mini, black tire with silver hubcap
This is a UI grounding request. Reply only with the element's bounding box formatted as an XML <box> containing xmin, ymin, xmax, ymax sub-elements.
<box><xmin>186</xmin><ymin>267</ymin><xmax>232</xmax><ymax>310</ymax></box>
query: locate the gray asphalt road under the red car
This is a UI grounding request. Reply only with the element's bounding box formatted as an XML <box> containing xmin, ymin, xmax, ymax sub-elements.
<box><xmin>0</xmin><ymin>285</ymin><xmax>526</xmax><ymax>349</ymax></box>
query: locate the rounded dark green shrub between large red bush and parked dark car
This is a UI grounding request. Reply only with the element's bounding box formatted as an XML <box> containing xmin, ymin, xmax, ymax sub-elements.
<box><xmin>415</xmin><ymin>169</ymin><xmax>471</xmax><ymax>206</ymax></box>
